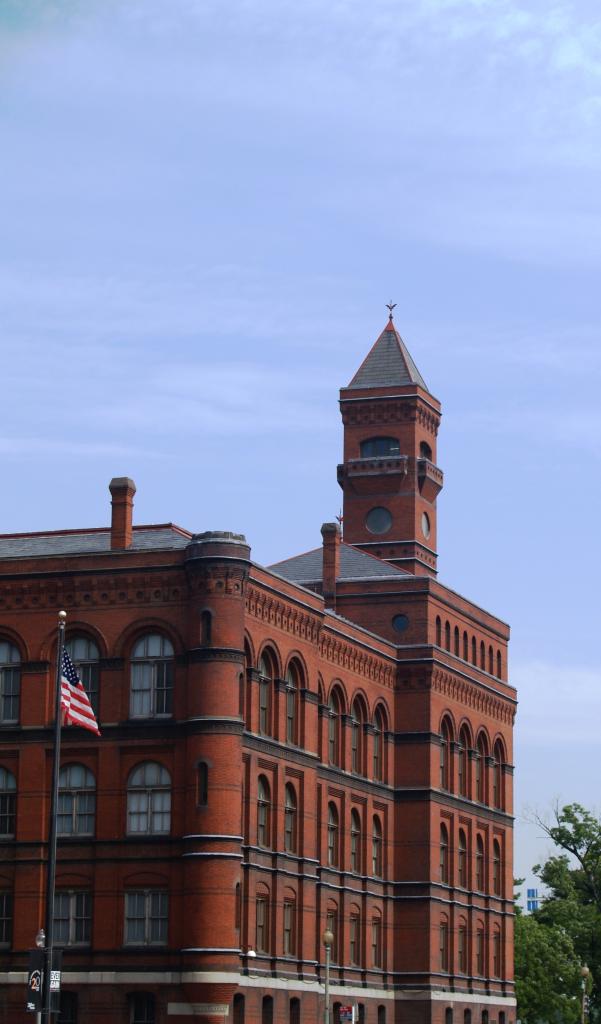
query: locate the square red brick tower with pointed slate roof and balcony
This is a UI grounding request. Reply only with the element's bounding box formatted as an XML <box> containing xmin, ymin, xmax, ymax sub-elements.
<box><xmin>338</xmin><ymin>307</ymin><xmax>442</xmax><ymax>575</ymax></box>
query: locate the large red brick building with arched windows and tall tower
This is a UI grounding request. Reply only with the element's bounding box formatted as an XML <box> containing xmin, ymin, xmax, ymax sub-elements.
<box><xmin>0</xmin><ymin>321</ymin><xmax>515</xmax><ymax>1024</ymax></box>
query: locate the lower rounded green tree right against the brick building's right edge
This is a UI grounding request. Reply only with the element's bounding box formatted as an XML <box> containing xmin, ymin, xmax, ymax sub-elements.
<box><xmin>515</xmin><ymin>914</ymin><xmax>581</xmax><ymax>1024</ymax></box>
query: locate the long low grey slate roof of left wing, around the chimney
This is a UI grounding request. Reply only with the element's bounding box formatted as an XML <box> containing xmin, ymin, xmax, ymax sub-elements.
<box><xmin>0</xmin><ymin>523</ymin><xmax>189</xmax><ymax>559</ymax></box>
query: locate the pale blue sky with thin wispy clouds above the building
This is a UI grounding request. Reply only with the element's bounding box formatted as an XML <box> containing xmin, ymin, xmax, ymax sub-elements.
<box><xmin>0</xmin><ymin>0</ymin><xmax>601</xmax><ymax>873</ymax></box>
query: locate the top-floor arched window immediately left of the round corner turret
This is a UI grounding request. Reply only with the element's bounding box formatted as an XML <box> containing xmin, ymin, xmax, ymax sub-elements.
<box><xmin>130</xmin><ymin>633</ymin><xmax>174</xmax><ymax>718</ymax></box>
